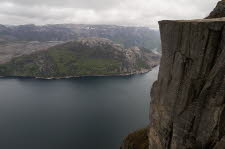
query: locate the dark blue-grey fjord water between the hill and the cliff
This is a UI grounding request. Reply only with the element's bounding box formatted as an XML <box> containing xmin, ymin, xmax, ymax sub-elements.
<box><xmin>0</xmin><ymin>67</ymin><xmax>158</xmax><ymax>149</ymax></box>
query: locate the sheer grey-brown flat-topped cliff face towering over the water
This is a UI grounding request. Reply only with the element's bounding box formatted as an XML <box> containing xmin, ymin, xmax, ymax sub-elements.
<box><xmin>149</xmin><ymin>18</ymin><xmax>225</xmax><ymax>149</ymax></box>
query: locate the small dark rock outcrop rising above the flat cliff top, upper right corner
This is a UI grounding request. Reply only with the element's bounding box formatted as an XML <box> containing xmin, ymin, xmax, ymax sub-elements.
<box><xmin>206</xmin><ymin>0</ymin><xmax>225</xmax><ymax>19</ymax></box>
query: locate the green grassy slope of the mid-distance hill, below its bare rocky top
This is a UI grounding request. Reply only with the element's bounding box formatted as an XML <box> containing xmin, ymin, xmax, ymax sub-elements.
<box><xmin>0</xmin><ymin>42</ymin><xmax>121</xmax><ymax>77</ymax></box>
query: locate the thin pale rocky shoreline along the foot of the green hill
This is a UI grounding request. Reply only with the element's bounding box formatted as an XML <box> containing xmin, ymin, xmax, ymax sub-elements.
<box><xmin>0</xmin><ymin>65</ymin><xmax>158</xmax><ymax>80</ymax></box>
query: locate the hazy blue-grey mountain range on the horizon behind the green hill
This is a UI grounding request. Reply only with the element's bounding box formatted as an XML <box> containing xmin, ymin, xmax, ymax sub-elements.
<box><xmin>0</xmin><ymin>24</ymin><xmax>160</xmax><ymax>50</ymax></box>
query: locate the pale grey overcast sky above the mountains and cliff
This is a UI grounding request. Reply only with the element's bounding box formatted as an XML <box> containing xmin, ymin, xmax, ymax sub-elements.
<box><xmin>0</xmin><ymin>0</ymin><xmax>218</xmax><ymax>28</ymax></box>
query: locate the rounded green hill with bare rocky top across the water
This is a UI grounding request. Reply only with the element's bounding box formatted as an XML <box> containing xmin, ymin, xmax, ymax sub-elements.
<box><xmin>0</xmin><ymin>38</ymin><xmax>160</xmax><ymax>78</ymax></box>
